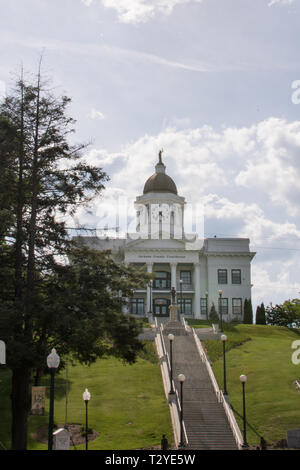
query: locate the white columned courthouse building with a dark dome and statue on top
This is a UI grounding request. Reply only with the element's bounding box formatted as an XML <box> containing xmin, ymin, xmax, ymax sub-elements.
<box><xmin>75</xmin><ymin>152</ymin><xmax>255</xmax><ymax>321</ymax></box>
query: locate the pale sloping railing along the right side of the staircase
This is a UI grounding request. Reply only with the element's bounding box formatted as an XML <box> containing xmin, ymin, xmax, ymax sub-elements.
<box><xmin>193</xmin><ymin>328</ymin><xmax>243</xmax><ymax>448</ymax></box>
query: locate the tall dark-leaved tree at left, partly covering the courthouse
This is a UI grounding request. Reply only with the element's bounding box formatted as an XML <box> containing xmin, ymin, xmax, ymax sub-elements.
<box><xmin>0</xmin><ymin>63</ymin><xmax>150</xmax><ymax>449</ymax></box>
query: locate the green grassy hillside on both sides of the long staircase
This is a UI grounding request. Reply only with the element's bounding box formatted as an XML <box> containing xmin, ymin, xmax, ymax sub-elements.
<box><xmin>0</xmin><ymin>322</ymin><xmax>300</xmax><ymax>450</ymax></box>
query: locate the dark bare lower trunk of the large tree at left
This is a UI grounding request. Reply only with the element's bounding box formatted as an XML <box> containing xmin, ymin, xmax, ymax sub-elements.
<box><xmin>11</xmin><ymin>368</ymin><xmax>31</xmax><ymax>450</ymax></box>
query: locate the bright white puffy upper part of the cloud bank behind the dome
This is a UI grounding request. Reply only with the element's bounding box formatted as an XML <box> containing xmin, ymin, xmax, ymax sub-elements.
<box><xmin>85</xmin><ymin>118</ymin><xmax>300</xmax><ymax>220</ymax></box>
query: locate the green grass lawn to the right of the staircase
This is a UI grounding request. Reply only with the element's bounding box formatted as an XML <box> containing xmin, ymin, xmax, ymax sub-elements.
<box><xmin>200</xmin><ymin>325</ymin><xmax>300</xmax><ymax>445</ymax></box>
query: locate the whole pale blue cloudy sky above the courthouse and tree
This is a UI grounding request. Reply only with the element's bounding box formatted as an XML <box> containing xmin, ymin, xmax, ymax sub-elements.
<box><xmin>0</xmin><ymin>0</ymin><xmax>300</xmax><ymax>307</ymax></box>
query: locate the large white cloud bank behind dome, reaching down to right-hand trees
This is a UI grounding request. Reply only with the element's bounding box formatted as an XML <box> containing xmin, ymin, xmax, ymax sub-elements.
<box><xmin>74</xmin><ymin>118</ymin><xmax>300</xmax><ymax>305</ymax></box>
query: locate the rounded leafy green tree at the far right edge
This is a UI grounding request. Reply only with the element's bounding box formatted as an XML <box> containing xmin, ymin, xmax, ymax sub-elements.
<box><xmin>266</xmin><ymin>299</ymin><xmax>300</xmax><ymax>328</ymax></box>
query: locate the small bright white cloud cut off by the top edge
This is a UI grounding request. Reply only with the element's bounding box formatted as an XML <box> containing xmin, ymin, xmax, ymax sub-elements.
<box><xmin>81</xmin><ymin>0</ymin><xmax>202</xmax><ymax>23</ymax></box>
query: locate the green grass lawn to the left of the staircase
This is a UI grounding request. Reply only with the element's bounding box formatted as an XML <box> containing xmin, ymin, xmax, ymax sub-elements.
<box><xmin>0</xmin><ymin>342</ymin><xmax>173</xmax><ymax>450</ymax></box>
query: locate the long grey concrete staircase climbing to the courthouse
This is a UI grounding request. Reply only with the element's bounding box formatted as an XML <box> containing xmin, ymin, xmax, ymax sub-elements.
<box><xmin>164</xmin><ymin>333</ymin><xmax>238</xmax><ymax>450</ymax></box>
